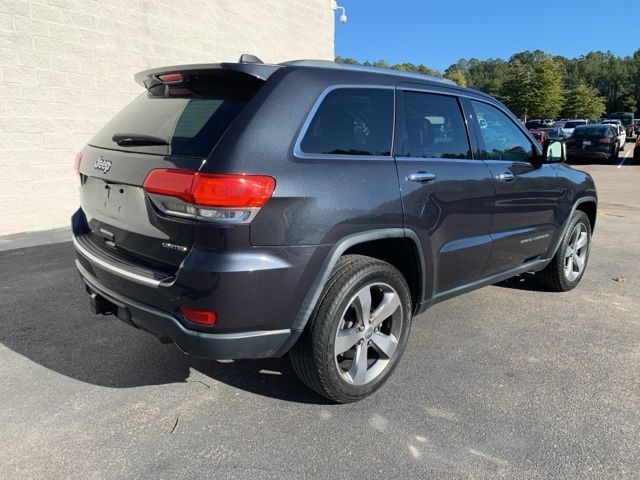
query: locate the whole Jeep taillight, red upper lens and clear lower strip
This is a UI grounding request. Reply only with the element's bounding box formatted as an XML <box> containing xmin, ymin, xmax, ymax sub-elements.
<box><xmin>144</xmin><ymin>169</ymin><xmax>276</xmax><ymax>223</ymax></box>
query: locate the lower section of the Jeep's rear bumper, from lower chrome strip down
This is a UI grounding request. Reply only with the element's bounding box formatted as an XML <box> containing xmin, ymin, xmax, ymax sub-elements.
<box><xmin>76</xmin><ymin>260</ymin><xmax>298</xmax><ymax>359</ymax></box>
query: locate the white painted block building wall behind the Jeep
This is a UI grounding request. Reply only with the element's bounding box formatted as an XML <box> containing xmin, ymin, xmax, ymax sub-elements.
<box><xmin>0</xmin><ymin>0</ymin><xmax>334</xmax><ymax>235</ymax></box>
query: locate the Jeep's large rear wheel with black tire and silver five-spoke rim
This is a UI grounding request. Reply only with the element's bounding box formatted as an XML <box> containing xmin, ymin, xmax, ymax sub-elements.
<box><xmin>289</xmin><ymin>255</ymin><xmax>412</xmax><ymax>403</ymax></box>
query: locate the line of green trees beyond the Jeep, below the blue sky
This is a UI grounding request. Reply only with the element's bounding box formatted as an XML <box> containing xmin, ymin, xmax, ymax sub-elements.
<box><xmin>336</xmin><ymin>50</ymin><xmax>640</xmax><ymax>118</ymax></box>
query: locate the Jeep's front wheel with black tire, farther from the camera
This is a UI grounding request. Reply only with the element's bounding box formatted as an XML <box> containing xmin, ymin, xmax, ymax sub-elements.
<box><xmin>536</xmin><ymin>210</ymin><xmax>591</xmax><ymax>292</ymax></box>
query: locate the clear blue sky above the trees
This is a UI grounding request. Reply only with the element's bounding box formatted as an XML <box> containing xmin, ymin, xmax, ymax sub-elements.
<box><xmin>335</xmin><ymin>0</ymin><xmax>640</xmax><ymax>71</ymax></box>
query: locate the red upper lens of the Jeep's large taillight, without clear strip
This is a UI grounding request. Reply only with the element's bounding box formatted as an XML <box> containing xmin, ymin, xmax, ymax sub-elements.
<box><xmin>144</xmin><ymin>169</ymin><xmax>276</xmax><ymax>208</ymax></box>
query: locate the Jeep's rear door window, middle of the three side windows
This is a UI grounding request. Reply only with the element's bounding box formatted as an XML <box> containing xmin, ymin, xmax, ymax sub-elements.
<box><xmin>399</xmin><ymin>92</ymin><xmax>470</xmax><ymax>158</ymax></box>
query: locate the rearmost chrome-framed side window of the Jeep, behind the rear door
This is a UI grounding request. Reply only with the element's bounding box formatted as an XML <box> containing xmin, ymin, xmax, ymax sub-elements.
<box><xmin>300</xmin><ymin>88</ymin><xmax>393</xmax><ymax>156</ymax></box>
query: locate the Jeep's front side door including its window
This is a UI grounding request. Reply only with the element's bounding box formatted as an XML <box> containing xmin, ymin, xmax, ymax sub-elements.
<box><xmin>466</xmin><ymin>100</ymin><xmax>563</xmax><ymax>276</ymax></box>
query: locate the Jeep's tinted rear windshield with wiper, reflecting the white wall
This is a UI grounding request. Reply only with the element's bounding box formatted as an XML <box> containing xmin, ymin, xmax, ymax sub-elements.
<box><xmin>89</xmin><ymin>73</ymin><xmax>263</xmax><ymax>157</ymax></box>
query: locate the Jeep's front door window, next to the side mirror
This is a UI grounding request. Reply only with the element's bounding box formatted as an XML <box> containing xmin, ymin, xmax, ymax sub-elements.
<box><xmin>471</xmin><ymin>100</ymin><xmax>535</xmax><ymax>162</ymax></box>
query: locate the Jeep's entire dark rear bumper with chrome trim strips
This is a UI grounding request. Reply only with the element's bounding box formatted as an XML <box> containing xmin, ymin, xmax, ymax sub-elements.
<box><xmin>72</xmin><ymin>210</ymin><xmax>329</xmax><ymax>359</ymax></box>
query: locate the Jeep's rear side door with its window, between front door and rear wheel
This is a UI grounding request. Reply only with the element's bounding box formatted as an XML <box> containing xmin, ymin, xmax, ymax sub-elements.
<box><xmin>395</xmin><ymin>86</ymin><xmax>494</xmax><ymax>297</ymax></box>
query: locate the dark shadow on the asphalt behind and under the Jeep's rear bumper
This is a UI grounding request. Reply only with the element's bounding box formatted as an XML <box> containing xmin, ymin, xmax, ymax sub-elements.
<box><xmin>0</xmin><ymin>243</ymin><xmax>327</xmax><ymax>404</ymax></box>
